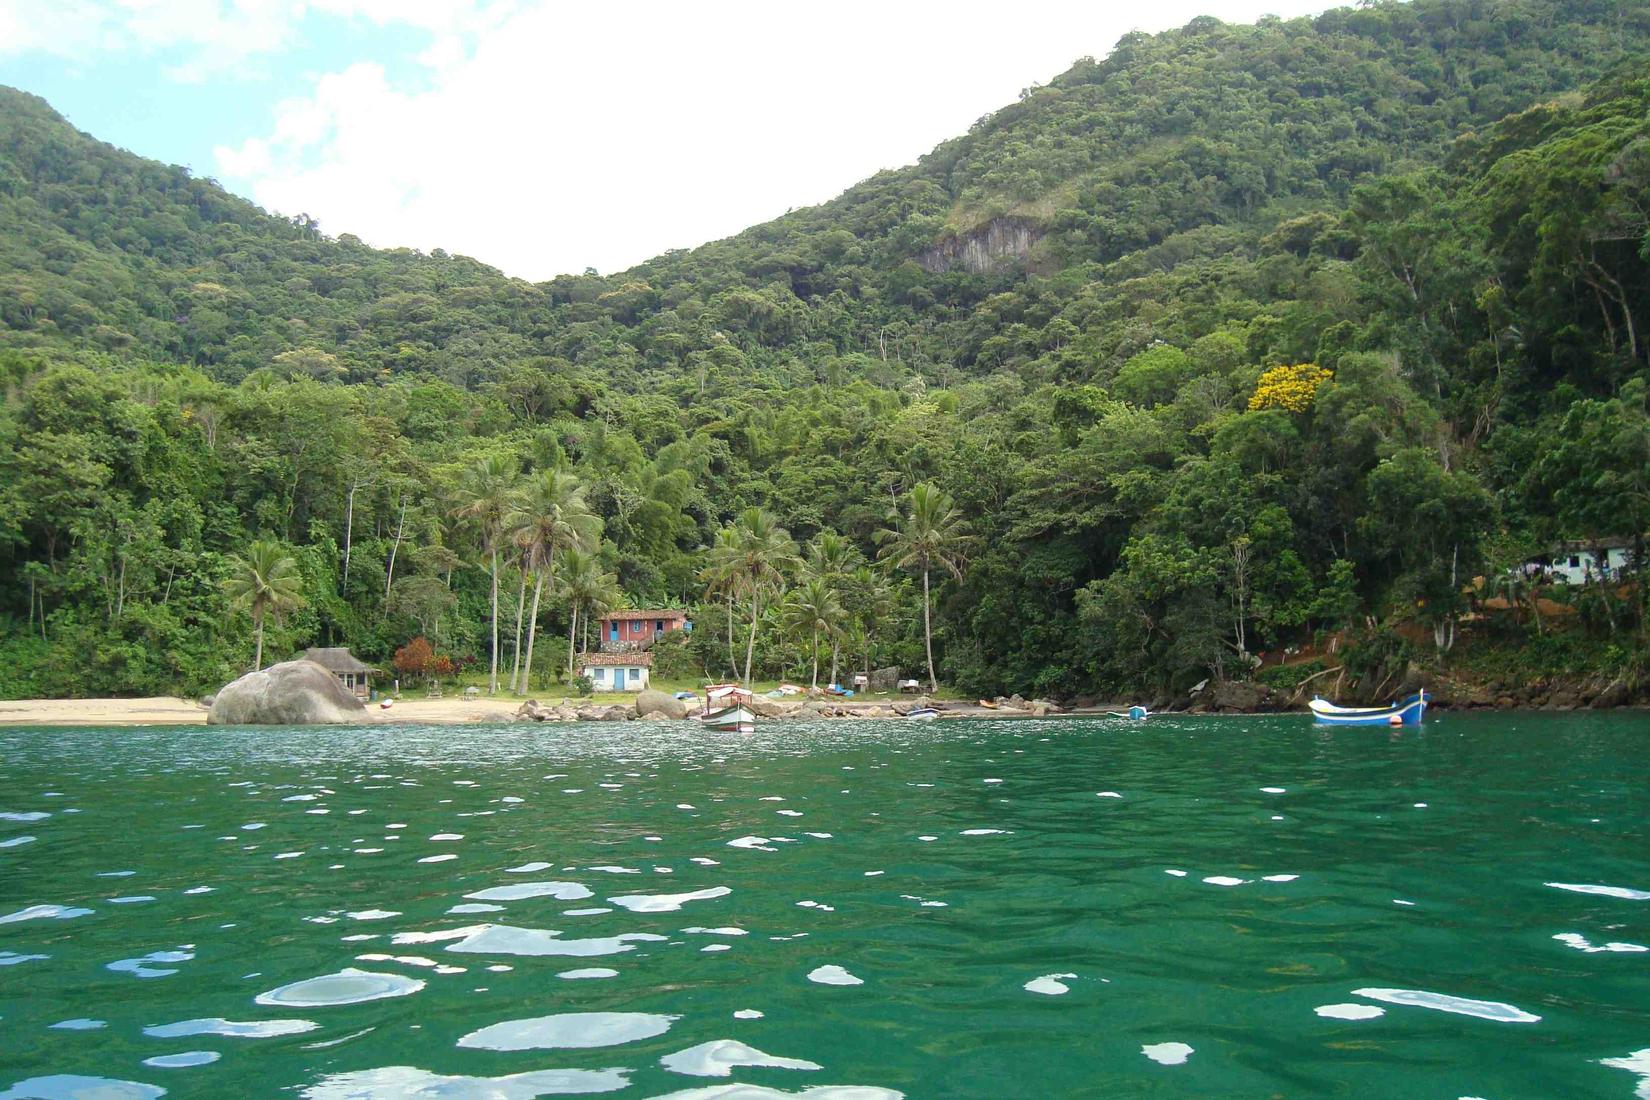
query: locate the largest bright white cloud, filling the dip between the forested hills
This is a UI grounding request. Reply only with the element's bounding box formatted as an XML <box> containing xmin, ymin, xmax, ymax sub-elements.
<box><xmin>216</xmin><ymin>0</ymin><xmax>1323</xmax><ymax>279</ymax></box>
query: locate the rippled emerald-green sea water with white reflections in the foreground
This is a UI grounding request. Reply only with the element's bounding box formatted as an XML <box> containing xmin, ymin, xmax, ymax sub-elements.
<box><xmin>0</xmin><ymin>714</ymin><xmax>1650</xmax><ymax>1100</ymax></box>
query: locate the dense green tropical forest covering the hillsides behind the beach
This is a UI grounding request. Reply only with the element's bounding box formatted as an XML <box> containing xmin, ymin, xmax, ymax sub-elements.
<box><xmin>0</xmin><ymin>0</ymin><xmax>1650</xmax><ymax>698</ymax></box>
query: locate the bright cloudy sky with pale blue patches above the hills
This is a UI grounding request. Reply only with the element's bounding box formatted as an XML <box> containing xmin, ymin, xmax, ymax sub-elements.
<box><xmin>0</xmin><ymin>0</ymin><xmax>1332</xmax><ymax>279</ymax></box>
